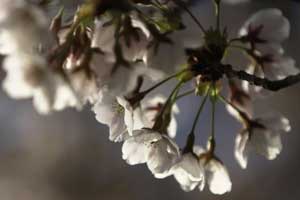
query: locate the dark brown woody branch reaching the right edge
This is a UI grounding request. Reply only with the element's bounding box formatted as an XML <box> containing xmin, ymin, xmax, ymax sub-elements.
<box><xmin>221</xmin><ymin>65</ymin><xmax>300</xmax><ymax>91</ymax></box>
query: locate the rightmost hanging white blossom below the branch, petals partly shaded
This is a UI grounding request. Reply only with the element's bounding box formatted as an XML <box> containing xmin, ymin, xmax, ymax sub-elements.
<box><xmin>235</xmin><ymin>115</ymin><xmax>291</xmax><ymax>168</ymax></box>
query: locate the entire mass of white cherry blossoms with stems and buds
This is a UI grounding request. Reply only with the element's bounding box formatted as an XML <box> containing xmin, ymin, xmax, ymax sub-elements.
<box><xmin>0</xmin><ymin>0</ymin><xmax>300</xmax><ymax>194</ymax></box>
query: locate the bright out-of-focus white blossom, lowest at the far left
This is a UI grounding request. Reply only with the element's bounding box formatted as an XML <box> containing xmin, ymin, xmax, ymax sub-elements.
<box><xmin>2</xmin><ymin>53</ymin><xmax>81</xmax><ymax>114</ymax></box>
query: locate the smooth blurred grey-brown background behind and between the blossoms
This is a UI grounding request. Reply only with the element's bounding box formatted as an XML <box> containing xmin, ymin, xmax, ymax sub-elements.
<box><xmin>0</xmin><ymin>0</ymin><xmax>300</xmax><ymax>200</ymax></box>
